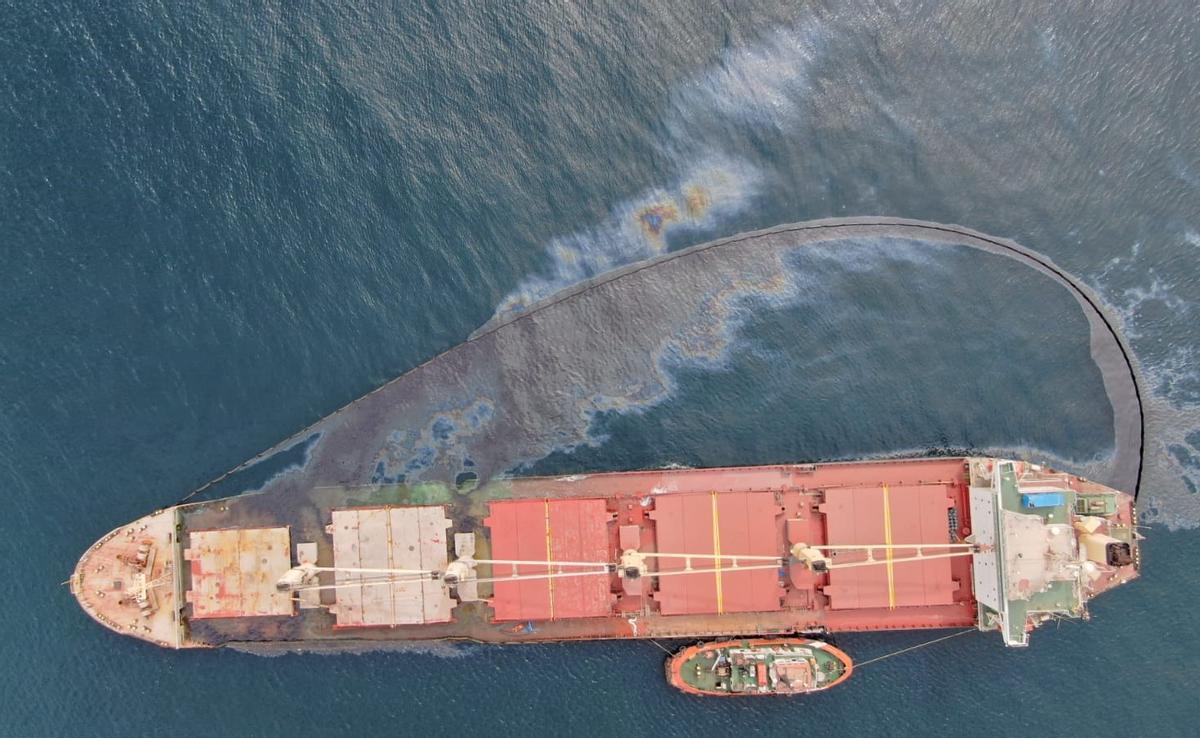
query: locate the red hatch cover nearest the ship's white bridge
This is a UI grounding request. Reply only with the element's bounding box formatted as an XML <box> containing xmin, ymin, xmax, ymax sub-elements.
<box><xmin>821</xmin><ymin>485</ymin><xmax>956</xmax><ymax>610</ymax></box>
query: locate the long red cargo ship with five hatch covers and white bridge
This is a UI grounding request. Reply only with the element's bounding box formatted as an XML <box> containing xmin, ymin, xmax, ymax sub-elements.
<box><xmin>70</xmin><ymin>457</ymin><xmax>1140</xmax><ymax>686</ymax></box>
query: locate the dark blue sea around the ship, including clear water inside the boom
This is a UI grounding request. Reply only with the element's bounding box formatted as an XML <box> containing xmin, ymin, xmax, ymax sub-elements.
<box><xmin>0</xmin><ymin>0</ymin><xmax>1200</xmax><ymax>736</ymax></box>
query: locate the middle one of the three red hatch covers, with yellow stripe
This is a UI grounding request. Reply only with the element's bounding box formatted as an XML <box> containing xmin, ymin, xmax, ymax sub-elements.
<box><xmin>650</xmin><ymin>492</ymin><xmax>784</xmax><ymax>614</ymax></box>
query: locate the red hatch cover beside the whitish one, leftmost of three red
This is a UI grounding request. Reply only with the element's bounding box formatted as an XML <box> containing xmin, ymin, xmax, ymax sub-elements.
<box><xmin>484</xmin><ymin>499</ymin><xmax>616</xmax><ymax>620</ymax></box>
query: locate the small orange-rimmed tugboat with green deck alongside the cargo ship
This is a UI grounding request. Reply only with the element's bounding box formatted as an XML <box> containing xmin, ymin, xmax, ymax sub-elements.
<box><xmin>667</xmin><ymin>638</ymin><xmax>854</xmax><ymax>697</ymax></box>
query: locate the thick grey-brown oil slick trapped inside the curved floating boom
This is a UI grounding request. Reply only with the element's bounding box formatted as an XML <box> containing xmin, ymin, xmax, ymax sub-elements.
<box><xmin>211</xmin><ymin>218</ymin><xmax>1129</xmax><ymax>554</ymax></box>
